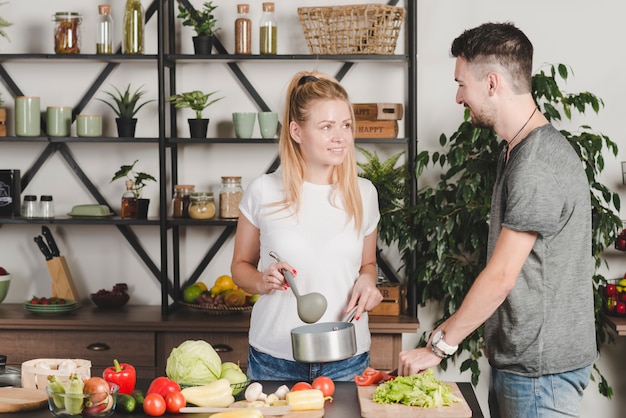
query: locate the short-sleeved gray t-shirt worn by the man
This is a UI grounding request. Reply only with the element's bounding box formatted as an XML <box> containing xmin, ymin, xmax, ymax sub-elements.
<box><xmin>485</xmin><ymin>124</ymin><xmax>597</xmax><ymax>376</ymax></box>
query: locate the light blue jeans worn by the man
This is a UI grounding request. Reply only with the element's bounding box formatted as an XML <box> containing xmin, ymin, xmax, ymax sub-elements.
<box><xmin>489</xmin><ymin>366</ymin><xmax>593</xmax><ymax>418</ymax></box>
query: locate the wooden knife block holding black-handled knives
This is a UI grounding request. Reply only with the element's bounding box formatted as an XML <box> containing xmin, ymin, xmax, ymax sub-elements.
<box><xmin>35</xmin><ymin>225</ymin><xmax>80</xmax><ymax>307</ymax></box>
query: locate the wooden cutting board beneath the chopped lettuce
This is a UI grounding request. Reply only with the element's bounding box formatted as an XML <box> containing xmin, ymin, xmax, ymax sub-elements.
<box><xmin>357</xmin><ymin>382</ymin><xmax>472</xmax><ymax>418</ymax></box>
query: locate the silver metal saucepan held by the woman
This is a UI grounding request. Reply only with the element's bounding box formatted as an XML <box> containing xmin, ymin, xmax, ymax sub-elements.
<box><xmin>291</xmin><ymin>322</ymin><xmax>356</xmax><ymax>363</ymax></box>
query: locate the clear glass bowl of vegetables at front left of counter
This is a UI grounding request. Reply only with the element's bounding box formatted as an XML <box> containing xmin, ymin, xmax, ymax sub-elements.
<box><xmin>46</xmin><ymin>383</ymin><xmax>119</xmax><ymax>418</ymax></box>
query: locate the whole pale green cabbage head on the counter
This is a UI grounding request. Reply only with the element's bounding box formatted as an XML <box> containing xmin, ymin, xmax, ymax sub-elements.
<box><xmin>165</xmin><ymin>340</ymin><xmax>222</xmax><ymax>386</ymax></box>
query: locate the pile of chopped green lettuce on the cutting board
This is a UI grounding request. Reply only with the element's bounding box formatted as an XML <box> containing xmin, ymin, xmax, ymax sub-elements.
<box><xmin>372</xmin><ymin>369</ymin><xmax>461</xmax><ymax>408</ymax></box>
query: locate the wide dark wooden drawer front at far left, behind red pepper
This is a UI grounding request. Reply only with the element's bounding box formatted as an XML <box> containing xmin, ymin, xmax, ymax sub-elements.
<box><xmin>2</xmin><ymin>331</ymin><xmax>156</xmax><ymax>378</ymax></box>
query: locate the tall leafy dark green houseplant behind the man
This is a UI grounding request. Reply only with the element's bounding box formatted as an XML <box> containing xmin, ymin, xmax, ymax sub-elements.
<box><xmin>363</xmin><ymin>64</ymin><xmax>622</xmax><ymax>398</ymax></box>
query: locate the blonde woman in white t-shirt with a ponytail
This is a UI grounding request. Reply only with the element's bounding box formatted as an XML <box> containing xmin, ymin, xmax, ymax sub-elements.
<box><xmin>231</xmin><ymin>72</ymin><xmax>382</xmax><ymax>381</ymax></box>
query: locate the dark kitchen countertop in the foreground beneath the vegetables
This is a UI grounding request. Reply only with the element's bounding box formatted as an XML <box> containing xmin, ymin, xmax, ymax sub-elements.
<box><xmin>0</xmin><ymin>380</ymin><xmax>484</xmax><ymax>418</ymax></box>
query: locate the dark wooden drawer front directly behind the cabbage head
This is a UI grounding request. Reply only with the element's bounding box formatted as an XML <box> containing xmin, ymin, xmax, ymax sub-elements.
<box><xmin>157</xmin><ymin>332</ymin><xmax>248</xmax><ymax>374</ymax></box>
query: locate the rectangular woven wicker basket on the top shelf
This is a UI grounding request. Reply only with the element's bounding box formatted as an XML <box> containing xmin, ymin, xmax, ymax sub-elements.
<box><xmin>298</xmin><ymin>4</ymin><xmax>406</xmax><ymax>55</ymax></box>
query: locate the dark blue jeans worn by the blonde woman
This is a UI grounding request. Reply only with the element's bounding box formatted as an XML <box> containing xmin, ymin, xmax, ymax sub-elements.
<box><xmin>247</xmin><ymin>347</ymin><xmax>370</xmax><ymax>382</ymax></box>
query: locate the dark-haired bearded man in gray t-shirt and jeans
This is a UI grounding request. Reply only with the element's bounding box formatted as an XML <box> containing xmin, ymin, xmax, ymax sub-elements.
<box><xmin>399</xmin><ymin>23</ymin><xmax>597</xmax><ymax>418</ymax></box>
